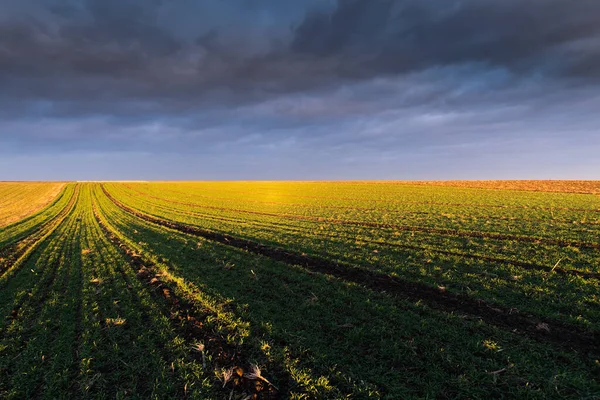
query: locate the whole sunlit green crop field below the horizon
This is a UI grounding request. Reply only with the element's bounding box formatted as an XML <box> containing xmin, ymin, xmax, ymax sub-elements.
<box><xmin>0</xmin><ymin>181</ymin><xmax>600</xmax><ymax>399</ymax></box>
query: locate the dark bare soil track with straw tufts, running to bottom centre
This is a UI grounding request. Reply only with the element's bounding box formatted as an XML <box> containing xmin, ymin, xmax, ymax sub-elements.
<box><xmin>94</xmin><ymin>206</ymin><xmax>281</xmax><ymax>399</ymax></box>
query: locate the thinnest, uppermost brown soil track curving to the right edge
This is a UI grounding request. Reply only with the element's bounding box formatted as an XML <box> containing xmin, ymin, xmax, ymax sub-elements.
<box><xmin>111</xmin><ymin>186</ymin><xmax>600</xmax><ymax>250</ymax></box>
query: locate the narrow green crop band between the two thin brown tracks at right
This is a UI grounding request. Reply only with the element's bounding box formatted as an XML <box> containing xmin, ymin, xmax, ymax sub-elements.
<box><xmin>131</xmin><ymin>200</ymin><xmax>599</xmax><ymax>277</ymax></box>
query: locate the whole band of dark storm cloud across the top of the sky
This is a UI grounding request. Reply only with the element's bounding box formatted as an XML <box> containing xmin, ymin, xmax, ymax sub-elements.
<box><xmin>0</xmin><ymin>0</ymin><xmax>600</xmax><ymax>106</ymax></box>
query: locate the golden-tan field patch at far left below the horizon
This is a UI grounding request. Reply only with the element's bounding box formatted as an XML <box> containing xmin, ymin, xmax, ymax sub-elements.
<box><xmin>0</xmin><ymin>182</ymin><xmax>64</xmax><ymax>227</ymax></box>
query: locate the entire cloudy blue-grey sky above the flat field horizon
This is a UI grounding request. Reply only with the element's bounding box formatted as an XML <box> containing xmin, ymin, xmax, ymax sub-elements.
<box><xmin>0</xmin><ymin>0</ymin><xmax>600</xmax><ymax>180</ymax></box>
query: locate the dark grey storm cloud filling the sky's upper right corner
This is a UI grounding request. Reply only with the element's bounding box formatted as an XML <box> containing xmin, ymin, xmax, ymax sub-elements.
<box><xmin>292</xmin><ymin>0</ymin><xmax>600</xmax><ymax>77</ymax></box>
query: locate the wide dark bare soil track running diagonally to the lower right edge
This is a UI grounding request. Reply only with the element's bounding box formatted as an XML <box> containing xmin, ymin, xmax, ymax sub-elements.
<box><xmin>105</xmin><ymin>191</ymin><xmax>600</xmax><ymax>354</ymax></box>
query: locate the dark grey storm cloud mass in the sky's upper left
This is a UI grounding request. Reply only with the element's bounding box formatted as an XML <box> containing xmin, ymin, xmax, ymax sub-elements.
<box><xmin>0</xmin><ymin>0</ymin><xmax>338</xmax><ymax>108</ymax></box>
